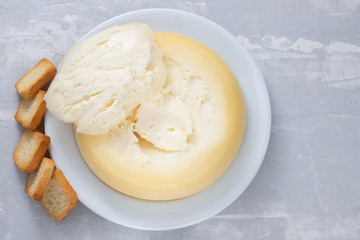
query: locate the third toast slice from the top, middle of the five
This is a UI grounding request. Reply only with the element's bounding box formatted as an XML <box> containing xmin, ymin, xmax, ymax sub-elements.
<box><xmin>13</xmin><ymin>129</ymin><xmax>50</xmax><ymax>173</ymax></box>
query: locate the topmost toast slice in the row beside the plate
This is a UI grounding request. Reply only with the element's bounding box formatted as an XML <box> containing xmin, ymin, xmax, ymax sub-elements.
<box><xmin>15</xmin><ymin>58</ymin><xmax>56</xmax><ymax>98</ymax></box>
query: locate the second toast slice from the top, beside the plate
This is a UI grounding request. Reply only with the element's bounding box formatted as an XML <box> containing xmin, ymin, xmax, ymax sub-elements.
<box><xmin>15</xmin><ymin>90</ymin><xmax>46</xmax><ymax>130</ymax></box>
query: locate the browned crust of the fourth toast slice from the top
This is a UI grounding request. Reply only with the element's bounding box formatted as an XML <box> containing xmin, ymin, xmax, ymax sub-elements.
<box><xmin>25</xmin><ymin>157</ymin><xmax>55</xmax><ymax>201</ymax></box>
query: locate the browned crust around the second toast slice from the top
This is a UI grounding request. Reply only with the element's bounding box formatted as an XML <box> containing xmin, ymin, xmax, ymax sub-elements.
<box><xmin>15</xmin><ymin>90</ymin><xmax>46</xmax><ymax>130</ymax></box>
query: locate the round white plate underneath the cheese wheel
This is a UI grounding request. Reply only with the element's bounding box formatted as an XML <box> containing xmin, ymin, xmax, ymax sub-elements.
<box><xmin>45</xmin><ymin>9</ymin><xmax>271</xmax><ymax>230</ymax></box>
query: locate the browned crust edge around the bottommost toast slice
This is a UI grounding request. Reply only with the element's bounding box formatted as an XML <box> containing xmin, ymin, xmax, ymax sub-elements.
<box><xmin>41</xmin><ymin>168</ymin><xmax>77</xmax><ymax>221</ymax></box>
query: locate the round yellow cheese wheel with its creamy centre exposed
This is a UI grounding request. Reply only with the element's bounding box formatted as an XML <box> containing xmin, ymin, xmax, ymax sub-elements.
<box><xmin>74</xmin><ymin>33</ymin><xmax>246</xmax><ymax>201</ymax></box>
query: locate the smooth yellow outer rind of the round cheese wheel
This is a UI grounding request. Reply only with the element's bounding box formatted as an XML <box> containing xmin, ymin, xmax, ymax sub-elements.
<box><xmin>75</xmin><ymin>33</ymin><xmax>246</xmax><ymax>200</ymax></box>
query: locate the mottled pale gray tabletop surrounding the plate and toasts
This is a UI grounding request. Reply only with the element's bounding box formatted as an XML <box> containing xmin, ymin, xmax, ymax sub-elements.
<box><xmin>0</xmin><ymin>0</ymin><xmax>360</xmax><ymax>240</ymax></box>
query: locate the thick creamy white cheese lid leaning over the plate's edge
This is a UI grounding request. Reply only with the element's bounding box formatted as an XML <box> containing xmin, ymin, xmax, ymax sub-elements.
<box><xmin>45</xmin><ymin>23</ymin><xmax>166</xmax><ymax>135</ymax></box>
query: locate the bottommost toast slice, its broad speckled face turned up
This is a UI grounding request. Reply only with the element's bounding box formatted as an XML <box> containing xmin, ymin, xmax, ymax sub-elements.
<box><xmin>41</xmin><ymin>168</ymin><xmax>77</xmax><ymax>221</ymax></box>
